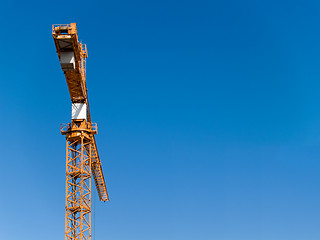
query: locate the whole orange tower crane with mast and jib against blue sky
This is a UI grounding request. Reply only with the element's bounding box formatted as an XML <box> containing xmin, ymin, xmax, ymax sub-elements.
<box><xmin>52</xmin><ymin>23</ymin><xmax>109</xmax><ymax>240</ymax></box>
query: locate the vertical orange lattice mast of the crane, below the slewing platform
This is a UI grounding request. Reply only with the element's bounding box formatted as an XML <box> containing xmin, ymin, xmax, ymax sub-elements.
<box><xmin>65</xmin><ymin>122</ymin><xmax>93</xmax><ymax>240</ymax></box>
